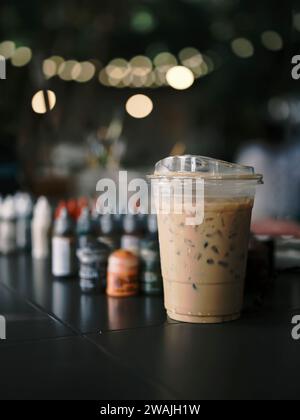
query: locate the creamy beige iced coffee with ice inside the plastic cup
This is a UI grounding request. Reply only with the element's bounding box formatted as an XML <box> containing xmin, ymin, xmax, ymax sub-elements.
<box><xmin>158</xmin><ymin>198</ymin><xmax>253</xmax><ymax>323</ymax></box>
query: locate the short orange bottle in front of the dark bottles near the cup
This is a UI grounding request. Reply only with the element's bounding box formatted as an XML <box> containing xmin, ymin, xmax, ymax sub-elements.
<box><xmin>106</xmin><ymin>249</ymin><xmax>139</xmax><ymax>297</ymax></box>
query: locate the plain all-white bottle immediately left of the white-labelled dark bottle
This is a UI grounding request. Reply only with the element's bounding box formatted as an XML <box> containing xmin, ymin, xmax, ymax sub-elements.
<box><xmin>31</xmin><ymin>197</ymin><xmax>52</xmax><ymax>259</ymax></box>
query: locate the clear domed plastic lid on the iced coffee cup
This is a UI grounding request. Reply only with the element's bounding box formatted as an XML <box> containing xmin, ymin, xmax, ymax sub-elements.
<box><xmin>150</xmin><ymin>155</ymin><xmax>263</xmax><ymax>183</ymax></box>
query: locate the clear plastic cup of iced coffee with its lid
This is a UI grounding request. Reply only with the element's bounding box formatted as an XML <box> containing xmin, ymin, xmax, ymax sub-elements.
<box><xmin>149</xmin><ymin>156</ymin><xmax>262</xmax><ymax>323</ymax></box>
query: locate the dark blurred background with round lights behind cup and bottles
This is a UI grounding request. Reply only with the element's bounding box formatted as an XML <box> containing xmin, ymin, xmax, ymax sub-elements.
<box><xmin>0</xmin><ymin>0</ymin><xmax>300</xmax><ymax>225</ymax></box>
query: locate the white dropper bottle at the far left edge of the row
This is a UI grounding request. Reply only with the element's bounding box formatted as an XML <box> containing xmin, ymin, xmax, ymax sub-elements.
<box><xmin>0</xmin><ymin>195</ymin><xmax>17</xmax><ymax>255</ymax></box>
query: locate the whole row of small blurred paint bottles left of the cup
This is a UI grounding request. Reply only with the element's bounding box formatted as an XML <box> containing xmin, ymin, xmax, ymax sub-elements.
<box><xmin>0</xmin><ymin>193</ymin><xmax>162</xmax><ymax>296</ymax></box>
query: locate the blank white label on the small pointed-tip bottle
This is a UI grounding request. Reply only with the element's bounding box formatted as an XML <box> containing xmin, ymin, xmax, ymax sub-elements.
<box><xmin>52</xmin><ymin>237</ymin><xmax>76</xmax><ymax>277</ymax></box>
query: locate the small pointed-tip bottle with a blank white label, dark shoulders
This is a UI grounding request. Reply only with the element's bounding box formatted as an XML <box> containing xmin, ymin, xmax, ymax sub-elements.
<box><xmin>52</xmin><ymin>208</ymin><xmax>77</xmax><ymax>277</ymax></box>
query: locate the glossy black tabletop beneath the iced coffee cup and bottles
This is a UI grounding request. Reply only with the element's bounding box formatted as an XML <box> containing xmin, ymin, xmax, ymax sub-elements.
<box><xmin>0</xmin><ymin>255</ymin><xmax>300</xmax><ymax>400</ymax></box>
